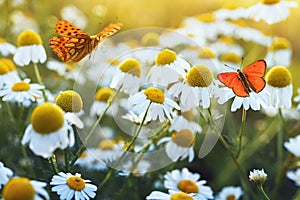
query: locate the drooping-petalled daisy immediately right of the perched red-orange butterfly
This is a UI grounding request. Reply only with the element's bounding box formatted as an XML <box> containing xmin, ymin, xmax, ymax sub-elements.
<box><xmin>264</xmin><ymin>66</ymin><xmax>293</xmax><ymax>108</ymax></box>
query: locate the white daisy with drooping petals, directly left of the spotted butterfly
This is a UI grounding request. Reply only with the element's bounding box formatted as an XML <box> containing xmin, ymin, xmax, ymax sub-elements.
<box><xmin>14</xmin><ymin>30</ymin><xmax>47</xmax><ymax>66</ymax></box>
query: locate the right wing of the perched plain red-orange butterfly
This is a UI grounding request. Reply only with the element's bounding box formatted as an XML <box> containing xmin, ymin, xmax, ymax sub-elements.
<box><xmin>242</xmin><ymin>60</ymin><xmax>267</xmax><ymax>93</ymax></box>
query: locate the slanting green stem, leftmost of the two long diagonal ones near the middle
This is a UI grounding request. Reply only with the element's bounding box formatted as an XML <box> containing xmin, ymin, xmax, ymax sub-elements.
<box><xmin>70</xmin><ymin>89</ymin><xmax>120</xmax><ymax>166</ymax></box>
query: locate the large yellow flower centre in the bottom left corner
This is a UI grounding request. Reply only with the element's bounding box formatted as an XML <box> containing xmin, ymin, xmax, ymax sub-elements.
<box><xmin>2</xmin><ymin>177</ymin><xmax>35</xmax><ymax>200</ymax></box>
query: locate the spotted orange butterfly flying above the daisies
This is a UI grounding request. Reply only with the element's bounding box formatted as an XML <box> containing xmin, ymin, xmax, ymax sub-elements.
<box><xmin>49</xmin><ymin>20</ymin><xmax>122</xmax><ymax>62</ymax></box>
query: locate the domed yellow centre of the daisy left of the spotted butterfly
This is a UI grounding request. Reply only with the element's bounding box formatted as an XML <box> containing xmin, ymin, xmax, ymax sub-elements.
<box><xmin>18</xmin><ymin>30</ymin><xmax>43</xmax><ymax>46</ymax></box>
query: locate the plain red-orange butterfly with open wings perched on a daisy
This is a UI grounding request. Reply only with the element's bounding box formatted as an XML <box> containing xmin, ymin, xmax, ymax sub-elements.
<box><xmin>218</xmin><ymin>60</ymin><xmax>267</xmax><ymax>97</ymax></box>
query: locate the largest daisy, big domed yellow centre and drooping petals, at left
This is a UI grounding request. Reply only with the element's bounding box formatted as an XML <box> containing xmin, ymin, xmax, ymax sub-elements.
<box><xmin>22</xmin><ymin>103</ymin><xmax>75</xmax><ymax>158</ymax></box>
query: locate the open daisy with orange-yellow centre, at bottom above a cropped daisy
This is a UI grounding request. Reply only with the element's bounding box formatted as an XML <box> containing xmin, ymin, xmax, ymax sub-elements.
<box><xmin>164</xmin><ymin>168</ymin><xmax>214</xmax><ymax>200</ymax></box>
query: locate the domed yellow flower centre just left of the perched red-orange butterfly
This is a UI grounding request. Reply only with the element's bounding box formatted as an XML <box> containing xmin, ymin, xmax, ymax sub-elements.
<box><xmin>186</xmin><ymin>65</ymin><xmax>213</xmax><ymax>87</ymax></box>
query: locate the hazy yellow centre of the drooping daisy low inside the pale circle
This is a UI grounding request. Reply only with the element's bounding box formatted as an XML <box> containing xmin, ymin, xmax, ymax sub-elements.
<box><xmin>172</xmin><ymin>129</ymin><xmax>195</xmax><ymax>148</ymax></box>
